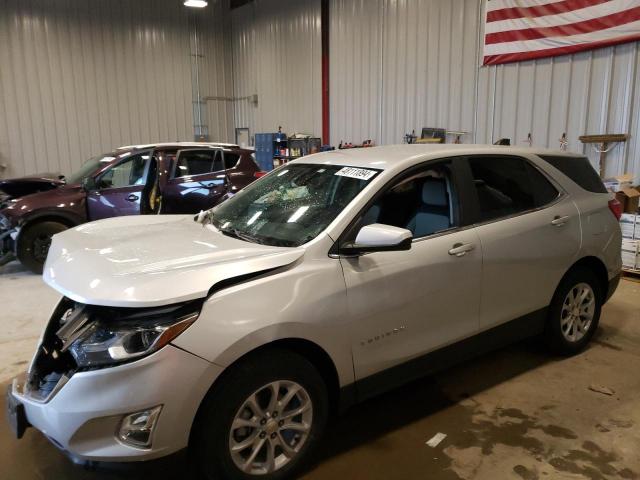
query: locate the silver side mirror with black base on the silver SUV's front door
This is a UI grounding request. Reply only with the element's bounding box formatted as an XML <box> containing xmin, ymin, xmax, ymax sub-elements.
<box><xmin>340</xmin><ymin>223</ymin><xmax>413</xmax><ymax>255</ymax></box>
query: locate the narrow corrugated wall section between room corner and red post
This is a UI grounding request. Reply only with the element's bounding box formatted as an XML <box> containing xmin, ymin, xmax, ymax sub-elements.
<box><xmin>231</xmin><ymin>0</ymin><xmax>322</xmax><ymax>141</ymax></box>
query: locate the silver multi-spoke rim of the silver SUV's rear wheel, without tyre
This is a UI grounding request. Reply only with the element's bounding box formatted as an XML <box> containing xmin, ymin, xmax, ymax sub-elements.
<box><xmin>560</xmin><ymin>283</ymin><xmax>596</xmax><ymax>343</ymax></box>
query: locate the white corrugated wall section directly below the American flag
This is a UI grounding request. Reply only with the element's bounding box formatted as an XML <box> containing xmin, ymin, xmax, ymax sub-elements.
<box><xmin>477</xmin><ymin>42</ymin><xmax>640</xmax><ymax>177</ymax></box>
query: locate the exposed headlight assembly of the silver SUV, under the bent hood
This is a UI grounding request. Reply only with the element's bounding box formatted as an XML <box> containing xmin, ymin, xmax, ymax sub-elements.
<box><xmin>56</xmin><ymin>300</ymin><xmax>203</xmax><ymax>368</ymax></box>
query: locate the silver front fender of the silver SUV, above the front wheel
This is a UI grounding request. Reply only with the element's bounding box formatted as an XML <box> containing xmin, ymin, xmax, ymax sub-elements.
<box><xmin>173</xmin><ymin>248</ymin><xmax>353</xmax><ymax>386</ymax></box>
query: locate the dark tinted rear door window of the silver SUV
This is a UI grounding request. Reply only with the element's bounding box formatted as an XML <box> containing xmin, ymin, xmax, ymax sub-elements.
<box><xmin>469</xmin><ymin>156</ymin><xmax>558</xmax><ymax>222</ymax></box>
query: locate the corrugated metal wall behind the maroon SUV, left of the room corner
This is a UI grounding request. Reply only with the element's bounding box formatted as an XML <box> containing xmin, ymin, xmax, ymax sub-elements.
<box><xmin>0</xmin><ymin>0</ymin><xmax>233</xmax><ymax>176</ymax></box>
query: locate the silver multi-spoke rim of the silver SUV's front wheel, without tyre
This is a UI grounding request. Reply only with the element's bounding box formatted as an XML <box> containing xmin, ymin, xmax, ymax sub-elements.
<box><xmin>229</xmin><ymin>380</ymin><xmax>313</xmax><ymax>475</ymax></box>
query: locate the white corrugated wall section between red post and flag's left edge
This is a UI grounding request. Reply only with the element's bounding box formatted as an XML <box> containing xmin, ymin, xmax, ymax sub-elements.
<box><xmin>330</xmin><ymin>0</ymin><xmax>480</xmax><ymax>143</ymax></box>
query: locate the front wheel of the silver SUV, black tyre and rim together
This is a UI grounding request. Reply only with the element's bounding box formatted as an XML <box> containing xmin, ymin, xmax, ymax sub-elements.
<box><xmin>191</xmin><ymin>350</ymin><xmax>328</xmax><ymax>480</ymax></box>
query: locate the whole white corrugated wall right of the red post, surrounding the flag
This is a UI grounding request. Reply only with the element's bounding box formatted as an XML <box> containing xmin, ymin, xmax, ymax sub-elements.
<box><xmin>330</xmin><ymin>0</ymin><xmax>640</xmax><ymax>181</ymax></box>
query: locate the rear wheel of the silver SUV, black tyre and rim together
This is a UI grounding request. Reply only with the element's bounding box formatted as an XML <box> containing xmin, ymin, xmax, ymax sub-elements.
<box><xmin>545</xmin><ymin>268</ymin><xmax>603</xmax><ymax>355</ymax></box>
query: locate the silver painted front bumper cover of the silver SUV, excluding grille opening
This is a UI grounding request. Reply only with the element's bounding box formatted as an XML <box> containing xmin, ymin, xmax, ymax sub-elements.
<box><xmin>12</xmin><ymin>345</ymin><xmax>222</xmax><ymax>462</ymax></box>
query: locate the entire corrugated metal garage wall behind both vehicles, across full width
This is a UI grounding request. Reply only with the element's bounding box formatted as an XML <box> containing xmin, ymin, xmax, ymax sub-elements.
<box><xmin>0</xmin><ymin>0</ymin><xmax>640</xmax><ymax>182</ymax></box>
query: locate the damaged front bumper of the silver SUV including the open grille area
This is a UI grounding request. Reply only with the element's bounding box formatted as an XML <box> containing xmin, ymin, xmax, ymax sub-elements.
<box><xmin>7</xmin><ymin>302</ymin><xmax>222</xmax><ymax>462</ymax></box>
